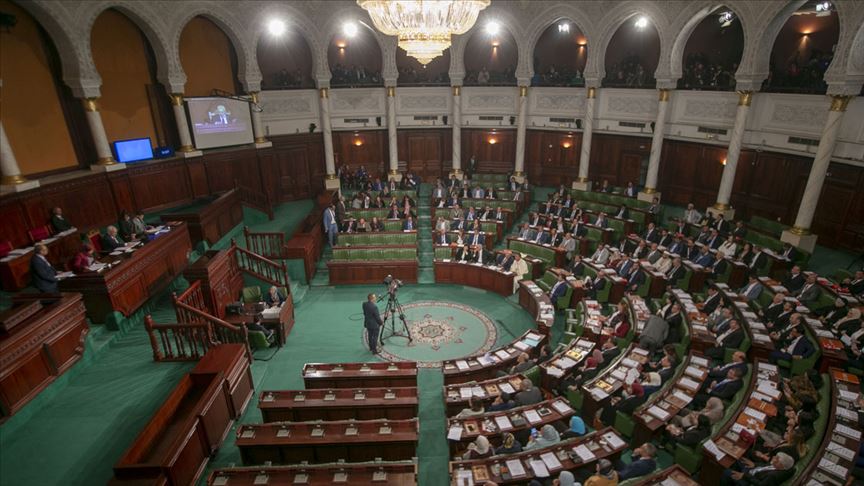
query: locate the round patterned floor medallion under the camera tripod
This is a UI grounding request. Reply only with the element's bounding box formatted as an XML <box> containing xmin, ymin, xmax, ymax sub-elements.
<box><xmin>363</xmin><ymin>301</ymin><xmax>497</xmax><ymax>368</ymax></box>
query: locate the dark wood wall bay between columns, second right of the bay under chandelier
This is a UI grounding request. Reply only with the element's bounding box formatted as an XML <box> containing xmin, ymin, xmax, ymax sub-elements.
<box><xmin>525</xmin><ymin>130</ymin><xmax>582</xmax><ymax>187</ymax></box>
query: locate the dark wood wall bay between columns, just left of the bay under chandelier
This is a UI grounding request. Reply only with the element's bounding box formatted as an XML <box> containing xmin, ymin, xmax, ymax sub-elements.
<box><xmin>333</xmin><ymin>130</ymin><xmax>390</xmax><ymax>178</ymax></box>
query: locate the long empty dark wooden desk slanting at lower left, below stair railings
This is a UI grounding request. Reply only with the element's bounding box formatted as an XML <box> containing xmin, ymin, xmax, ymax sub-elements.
<box><xmin>112</xmin><ymin>345</ymin><xmax>240</xmax><ymax>486</ymax></box>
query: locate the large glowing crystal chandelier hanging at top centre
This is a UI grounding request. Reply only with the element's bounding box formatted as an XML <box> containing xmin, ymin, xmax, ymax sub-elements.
<box><xmin>357</xmin><ymin>0</ymin><xmax>490</xmax><ymax>66</ymax></box>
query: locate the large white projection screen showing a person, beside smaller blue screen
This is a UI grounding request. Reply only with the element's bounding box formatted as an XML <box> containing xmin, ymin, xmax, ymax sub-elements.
<box><xmin>186</xmin><ymin>98</ymin><xmax>254</xmax><ymax>149</ymax></box>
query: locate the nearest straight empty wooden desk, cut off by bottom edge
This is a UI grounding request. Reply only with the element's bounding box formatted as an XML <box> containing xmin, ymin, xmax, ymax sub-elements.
<box><xmin>207</xmin><ymin>461</ymin><xmax>417</xmax><ymax>486</ymax></box>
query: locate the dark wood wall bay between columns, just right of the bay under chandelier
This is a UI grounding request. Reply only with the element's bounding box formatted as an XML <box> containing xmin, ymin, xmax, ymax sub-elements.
<box><xmin>462</xmin><ymin>128</ymin><xmax>516</xmax><ymax>173</ymax></box>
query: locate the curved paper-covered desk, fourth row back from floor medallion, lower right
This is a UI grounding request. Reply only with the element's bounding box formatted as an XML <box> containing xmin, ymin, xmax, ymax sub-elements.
<box><xmin>630</xmin><ymin>352</ymin><xmax>711</xmax><ymax>447</ymax></box>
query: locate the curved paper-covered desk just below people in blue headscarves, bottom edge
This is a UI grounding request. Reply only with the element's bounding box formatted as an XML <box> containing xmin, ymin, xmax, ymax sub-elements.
<box><xmin>450</xmin><ymin>427</ymin><xmax>627</xmax><ymax>485</ymax></box>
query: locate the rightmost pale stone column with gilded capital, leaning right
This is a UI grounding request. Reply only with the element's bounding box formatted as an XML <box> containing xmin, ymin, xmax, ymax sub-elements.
<box><xmin>780</xmin><ymin>95</ymin><xmax>852</xmax><ymax>253</ymax></box>
